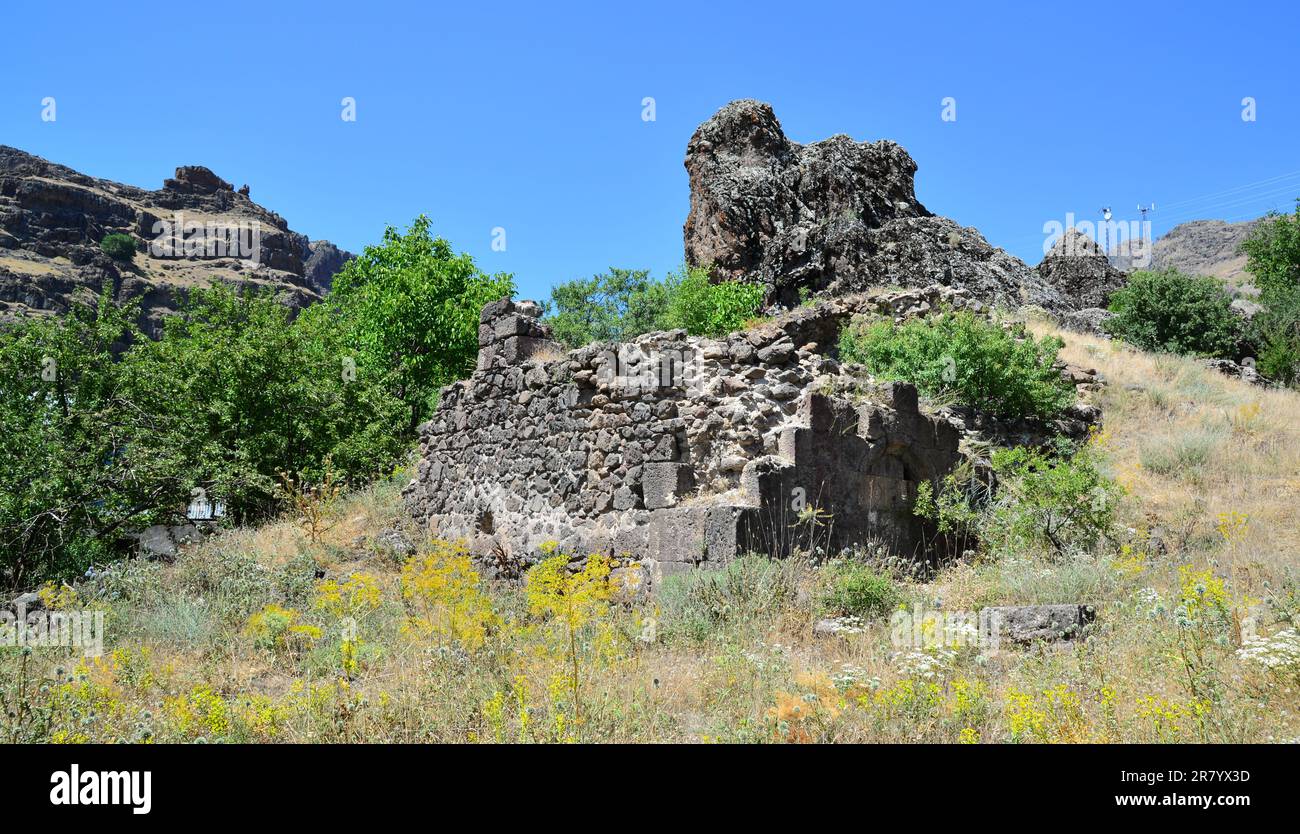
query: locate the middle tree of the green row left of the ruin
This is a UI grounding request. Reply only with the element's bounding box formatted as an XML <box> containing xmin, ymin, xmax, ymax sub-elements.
<box><xmin>122</xmin><ymin>286</ymin><xmax>407</xmax><ymax>520</ymax></box>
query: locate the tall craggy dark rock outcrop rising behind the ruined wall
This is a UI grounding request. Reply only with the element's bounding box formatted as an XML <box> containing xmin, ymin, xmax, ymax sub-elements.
<box><xmin>684</xmin><ymin>100</ymin><xmax>1075</xmax><ymax>310</ymax></box>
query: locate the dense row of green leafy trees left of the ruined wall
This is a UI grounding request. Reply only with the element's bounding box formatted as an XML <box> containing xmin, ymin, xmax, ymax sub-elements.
<box><xmin>0</xmin><ymin>217</ymin><xmax>501</xmax><ymax>587</ymax></box>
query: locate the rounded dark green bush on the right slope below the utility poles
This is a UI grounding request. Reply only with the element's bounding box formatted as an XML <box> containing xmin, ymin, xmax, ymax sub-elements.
<box><xmin>1105</xmin><ymin>269</ymin><xmax>1242</xmax><ymax>359</ymax></box>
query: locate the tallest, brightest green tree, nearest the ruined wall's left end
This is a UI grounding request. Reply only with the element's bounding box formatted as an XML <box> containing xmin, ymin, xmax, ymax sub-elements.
<box><xmin>329</xmin><ymin>214</ymin><xmax>515</xmax><ymax>435</ymax></box>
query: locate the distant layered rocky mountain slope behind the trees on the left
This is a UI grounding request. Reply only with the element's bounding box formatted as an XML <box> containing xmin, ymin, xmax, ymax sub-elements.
<box><xmin>0</xmin><ymin>145</ymin><xmax>351</xmax><ymax>336</ymax></box>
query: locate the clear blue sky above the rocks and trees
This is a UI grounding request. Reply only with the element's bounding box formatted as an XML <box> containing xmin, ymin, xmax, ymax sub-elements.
<box><xmin>0</xmin><ymin>0</ymin><xmax>1300</xmax><ymax>297</ymax></box>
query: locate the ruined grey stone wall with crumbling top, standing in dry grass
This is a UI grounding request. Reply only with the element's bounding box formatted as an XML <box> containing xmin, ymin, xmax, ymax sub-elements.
<box><xmin>406</xmin><ymin>287</ymin><xmax>979</xmax><ymax>566</ymax></box>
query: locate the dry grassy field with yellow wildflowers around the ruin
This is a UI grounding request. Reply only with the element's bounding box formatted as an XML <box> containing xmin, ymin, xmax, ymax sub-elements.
<box><xmin>0</xmin><ymin>323</ymin><xmax>1300</xmax><ymax>743</ymax></box>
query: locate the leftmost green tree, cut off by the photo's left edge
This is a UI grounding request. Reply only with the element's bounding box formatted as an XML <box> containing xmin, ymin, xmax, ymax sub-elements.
<box><xmin>0</xmin><ymin>295</ymin><xmax>181</xmax><ymax>587</ymax></box>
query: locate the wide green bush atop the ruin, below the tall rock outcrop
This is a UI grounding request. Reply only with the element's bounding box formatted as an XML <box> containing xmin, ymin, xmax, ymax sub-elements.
<box><xmin>840</xmin><ymin>310</ymin><xmax>1074</xmax><ymax>417</ymax></box>
